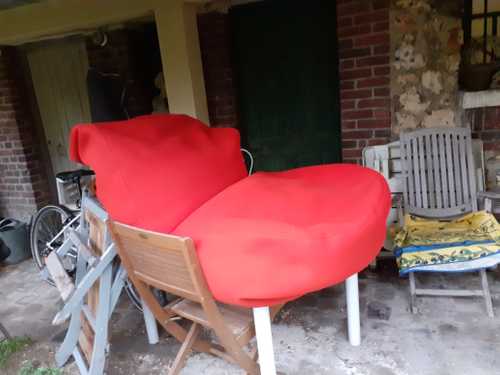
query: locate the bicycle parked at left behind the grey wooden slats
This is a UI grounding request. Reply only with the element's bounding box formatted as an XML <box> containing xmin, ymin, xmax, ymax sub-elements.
<box><xmin>30</xmin><ymin>169</ymin><xmax>142</xmax><ymax>311</ymax></box>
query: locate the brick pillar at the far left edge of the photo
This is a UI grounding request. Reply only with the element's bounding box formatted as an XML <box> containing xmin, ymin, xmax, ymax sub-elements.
<box><xmin>0</xmin><ymin>47</ymin><xmax>50</xmax><ymax>221</ymax></box>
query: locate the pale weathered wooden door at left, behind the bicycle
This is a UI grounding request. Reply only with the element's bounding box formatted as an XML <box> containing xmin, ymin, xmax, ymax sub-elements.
<box><xmin>26</xmin><ymin>38</ymin><xmax>90</xmax><ymax>173</ymax></box>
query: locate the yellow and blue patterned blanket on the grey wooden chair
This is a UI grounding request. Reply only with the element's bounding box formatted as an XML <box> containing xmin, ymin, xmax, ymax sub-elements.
<box><xmin>394</xmin><ymin>211</ymin><xmax>500</xmax><ymax>275</ymax></box>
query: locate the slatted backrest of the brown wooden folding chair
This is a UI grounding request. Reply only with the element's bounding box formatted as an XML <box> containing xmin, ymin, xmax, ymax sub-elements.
<box><xmin>110</xmin><ymin>222</ymin><xmax>213</xmax><ymax>303</ymax></box>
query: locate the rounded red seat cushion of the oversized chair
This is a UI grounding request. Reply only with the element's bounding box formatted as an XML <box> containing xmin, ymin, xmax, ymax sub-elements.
<box><xmin>174</xmin><ymin>164</ymin><xmax>390</xmax><ymax>307</ymax></box>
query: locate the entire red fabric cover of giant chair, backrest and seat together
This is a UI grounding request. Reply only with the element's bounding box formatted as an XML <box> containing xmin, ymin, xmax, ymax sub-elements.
<box><xmin>71</xmin><ymin>115</ymin><xmax>390</xmax><ymax>307</ymax></box>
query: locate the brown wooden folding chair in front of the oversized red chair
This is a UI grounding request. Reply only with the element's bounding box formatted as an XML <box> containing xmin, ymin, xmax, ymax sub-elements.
<box><xmin>109</xmin><ymin>221</ymin><xmax>281</xmax><ymax>375</ymax></box>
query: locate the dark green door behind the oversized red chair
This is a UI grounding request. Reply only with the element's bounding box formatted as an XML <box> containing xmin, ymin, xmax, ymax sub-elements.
<box><xmin>231</xmin><ymin>0</ymin><xmax>341</xmax><ymax>171</ymax></box>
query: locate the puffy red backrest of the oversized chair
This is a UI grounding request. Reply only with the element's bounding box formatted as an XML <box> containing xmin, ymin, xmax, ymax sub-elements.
<box><xmin>70</xmin><ymin>115</ymin><xmax>247</xmax><ymax>233</ymax></box>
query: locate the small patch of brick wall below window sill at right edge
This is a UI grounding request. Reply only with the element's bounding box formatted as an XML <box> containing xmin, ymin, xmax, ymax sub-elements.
<box><xmin>466</xmin><ymin>107</ymin><xmax>500</xmax><ymax>155</ymax></box>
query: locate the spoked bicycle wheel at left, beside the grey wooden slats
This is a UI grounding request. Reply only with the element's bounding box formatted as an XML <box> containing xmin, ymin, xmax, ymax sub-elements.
<box><xmin>30</xmin><ymin>206</ymin><xmax>79</xmax><ymax>285</ymax></box>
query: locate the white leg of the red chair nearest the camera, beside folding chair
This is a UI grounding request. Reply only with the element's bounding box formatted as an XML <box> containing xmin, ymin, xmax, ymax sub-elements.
<box><xmin>253</xmin><ymin>307</ymin><xmax>276</xmax><ymax>375</ymax></box>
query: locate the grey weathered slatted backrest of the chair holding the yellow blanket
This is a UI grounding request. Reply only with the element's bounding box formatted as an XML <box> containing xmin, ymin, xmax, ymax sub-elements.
<box><xmin>401</xmin><ymin>128</ymin><xmax>477</xmax><ymax>218</ymax></box>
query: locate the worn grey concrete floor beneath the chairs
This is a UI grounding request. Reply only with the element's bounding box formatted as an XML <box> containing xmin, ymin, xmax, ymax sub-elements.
<box><xmin>0</xmin><ymin>262</ymin><xmax>500</xmax><ymax>375</ymax></box>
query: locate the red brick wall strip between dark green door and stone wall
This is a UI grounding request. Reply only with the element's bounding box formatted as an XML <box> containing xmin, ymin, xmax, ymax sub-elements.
<box><xmin>337</xmin><ymin>0</ymin><xmax>391</xmax><ymax>163</ymax></box>
